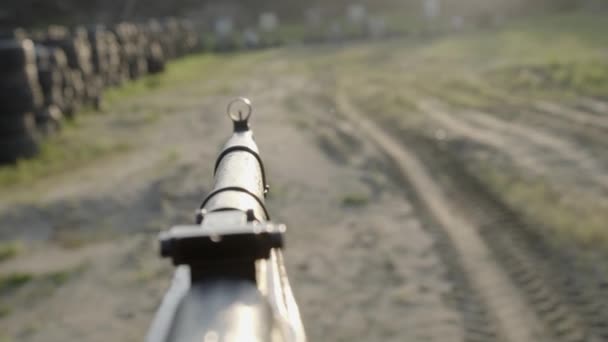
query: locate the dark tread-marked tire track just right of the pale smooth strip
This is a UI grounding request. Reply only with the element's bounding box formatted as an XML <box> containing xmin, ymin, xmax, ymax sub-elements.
<box><xmin>400</xmin><ymin>135</ymin><xmax>608</xmax><ymax>342</ymax></box>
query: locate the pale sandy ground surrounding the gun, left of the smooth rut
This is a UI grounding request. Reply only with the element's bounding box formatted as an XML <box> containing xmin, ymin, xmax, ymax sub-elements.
<box><xmin>0</xmin><ymin>55</ymin><xmax>463</xmax><ymax>342</ymax></box>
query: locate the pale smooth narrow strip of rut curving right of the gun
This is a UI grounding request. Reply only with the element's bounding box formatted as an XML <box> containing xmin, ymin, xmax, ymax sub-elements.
<box><xmin>336</xmin><ymin>95</ymin><xmax>548</xmax><ymax>342</ymax></box>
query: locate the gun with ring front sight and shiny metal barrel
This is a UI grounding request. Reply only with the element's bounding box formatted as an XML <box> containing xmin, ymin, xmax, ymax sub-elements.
<box><xmin>147</xmin><ymin>98</ymin><xmax>306</xmax><ymax>342</ymax></box>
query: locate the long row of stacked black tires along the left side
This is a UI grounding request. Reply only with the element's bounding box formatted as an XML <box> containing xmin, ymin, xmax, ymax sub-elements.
<box><xmin>0</xmin><ymin>18</ymin><xmax>200</xmax><ymax>164</ymax></box>
